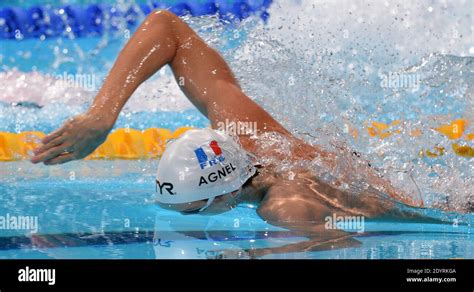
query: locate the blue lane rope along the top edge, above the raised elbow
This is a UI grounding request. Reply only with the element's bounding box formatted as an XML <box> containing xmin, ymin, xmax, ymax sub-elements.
<box><xmin>0</xmin><ymin>0</ymin><xmax>273</xmax><ymax>39</ymax></box>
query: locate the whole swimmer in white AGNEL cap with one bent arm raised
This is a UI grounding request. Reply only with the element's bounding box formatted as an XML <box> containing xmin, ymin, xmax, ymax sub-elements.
<box><xmin>31</xmin><ymin>10</ymin><xmax>442</xmax><ymax>246</ymax></box>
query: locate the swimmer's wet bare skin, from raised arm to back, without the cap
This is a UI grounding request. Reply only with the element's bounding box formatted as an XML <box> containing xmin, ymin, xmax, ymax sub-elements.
<box><xmin>31</xmin><ymin>11</ymin><xmax>436</xmax><ymax>254</ymax></box>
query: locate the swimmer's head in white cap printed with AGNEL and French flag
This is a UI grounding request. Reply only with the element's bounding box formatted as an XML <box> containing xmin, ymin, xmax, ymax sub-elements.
<box><xmin>156</xmin><ymin>129</ymin><xmax>256</xmax><ymax>214</ymax></box>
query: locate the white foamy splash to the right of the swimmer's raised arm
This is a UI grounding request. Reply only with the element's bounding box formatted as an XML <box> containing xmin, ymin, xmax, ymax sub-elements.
<box><xmin>220</xmin><ymin>1</ymin><xmax>474</xmax><ymax>211</ymax></box>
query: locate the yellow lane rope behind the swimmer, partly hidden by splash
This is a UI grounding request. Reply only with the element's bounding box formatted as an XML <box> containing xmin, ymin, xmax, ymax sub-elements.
<box><xmin>0</xmin><ymin>119</ymin><xmax>474</xmax><ymax>161</ymax></box>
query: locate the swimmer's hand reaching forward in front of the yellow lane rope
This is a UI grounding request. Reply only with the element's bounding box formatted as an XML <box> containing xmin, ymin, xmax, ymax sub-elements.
<box><xmin>31</xmin><ymin>113</ymin><xmax>113</xmax><ymax>165</ymax></box>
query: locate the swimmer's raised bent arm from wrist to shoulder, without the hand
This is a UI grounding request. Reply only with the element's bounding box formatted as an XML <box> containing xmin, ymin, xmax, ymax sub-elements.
<box><xmin>89</xmin><ymin>10</ymin><xmax>288</xmax><ymax>133</ymax></box>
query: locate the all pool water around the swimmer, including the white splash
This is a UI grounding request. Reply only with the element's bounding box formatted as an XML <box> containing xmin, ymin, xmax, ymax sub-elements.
<box><xmin>0</xmin><ymin>0</ymin><xmax>474</xmax><ymax>259</ymax></box>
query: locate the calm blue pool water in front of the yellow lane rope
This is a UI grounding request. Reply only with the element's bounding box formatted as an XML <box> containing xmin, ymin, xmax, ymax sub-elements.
<box><xmin>0</xmin><ymin>161</ymin><xmax>474</xmax><ymax>259</ymax></box>
